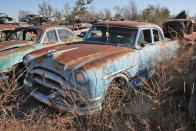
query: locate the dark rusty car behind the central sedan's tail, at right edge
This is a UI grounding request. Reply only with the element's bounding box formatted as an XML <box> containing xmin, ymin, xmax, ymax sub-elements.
<box><xmin>163</xmin><ymin>19</ymin><xmax>196</xmax><ymax>44</ymax></box>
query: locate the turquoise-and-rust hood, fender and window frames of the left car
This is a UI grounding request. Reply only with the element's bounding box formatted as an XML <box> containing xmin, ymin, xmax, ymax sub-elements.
<box><xmin>0</xmin><ymin>27</ymin><xmax>76</xmax><ymax>73</ymax></box>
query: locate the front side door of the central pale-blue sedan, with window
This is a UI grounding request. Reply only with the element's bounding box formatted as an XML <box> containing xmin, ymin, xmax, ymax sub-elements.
<box><xmin>136</xmin><ymin>29</ymin><xmax>160</xmax><ymax>81</ymax></box>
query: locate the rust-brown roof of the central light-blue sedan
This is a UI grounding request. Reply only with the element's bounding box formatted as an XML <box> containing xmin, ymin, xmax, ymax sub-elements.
<box><xmin>95</xmin><ymin>21</ymin><xmax>160</xmax><ymax>28</ymax></box>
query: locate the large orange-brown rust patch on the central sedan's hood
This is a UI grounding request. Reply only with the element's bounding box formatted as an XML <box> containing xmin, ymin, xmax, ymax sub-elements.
<box><xmin>56</xmin><ymin>44</ymin><xmax>133</xmax><ymax>68</ymax></box>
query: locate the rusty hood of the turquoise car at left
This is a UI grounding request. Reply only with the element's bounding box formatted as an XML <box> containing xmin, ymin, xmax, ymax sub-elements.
<box><xmin>0</xmin><ymin>41</ymin><xmax>32</xmax><ymax>51</ymax></box>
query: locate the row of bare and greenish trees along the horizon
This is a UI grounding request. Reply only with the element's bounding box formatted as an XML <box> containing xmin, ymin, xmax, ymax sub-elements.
<box><xmin>18</xmin><ymin>0</ymin><xmax>171</xmax><ymax>25</ymax></box>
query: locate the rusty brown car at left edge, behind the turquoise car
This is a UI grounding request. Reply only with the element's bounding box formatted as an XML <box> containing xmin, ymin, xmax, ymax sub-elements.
<box><xmin>0</xmin><ymin>25</ymin><xmax>19</xmax><ymax>42</ymax></box>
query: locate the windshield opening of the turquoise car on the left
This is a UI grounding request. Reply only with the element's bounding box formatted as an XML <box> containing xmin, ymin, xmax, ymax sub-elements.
<box><xmin>7</xmin><ymin>29</ymin><xmax>41</xmax><ymax>42</ymax></box>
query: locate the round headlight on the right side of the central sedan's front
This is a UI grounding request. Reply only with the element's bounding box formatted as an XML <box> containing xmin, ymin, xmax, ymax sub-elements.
<box><xmin>75</xmin><ymin>70</ymin><xmax>88</xmax><ymax>85</ymax></box>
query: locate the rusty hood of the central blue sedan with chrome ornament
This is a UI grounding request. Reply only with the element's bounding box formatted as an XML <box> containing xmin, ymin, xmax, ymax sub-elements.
<box><xmin>33</xmin><ymin>44</ymin><xmax>133</xmax><ymax>69</ymax></box>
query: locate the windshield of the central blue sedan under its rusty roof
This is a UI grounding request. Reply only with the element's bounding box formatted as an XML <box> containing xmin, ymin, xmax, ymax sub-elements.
<box><xmin>84</xmin><ymin>26</ymin><xmax>137</xmax><ymax>47</ymax></box>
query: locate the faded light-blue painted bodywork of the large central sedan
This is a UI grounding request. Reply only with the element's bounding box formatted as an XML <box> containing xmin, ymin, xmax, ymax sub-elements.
<box><xmin>24</xmin><ymin>23</ymin><xmax>179</xmax><ymax>114</ymax></box>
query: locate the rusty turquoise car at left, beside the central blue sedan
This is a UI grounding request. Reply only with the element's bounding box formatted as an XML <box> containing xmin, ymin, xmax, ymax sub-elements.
<box><xmin>0</xmin><ymin>25</ymin><xmax>77</xmax><ymax>81</ymax></box>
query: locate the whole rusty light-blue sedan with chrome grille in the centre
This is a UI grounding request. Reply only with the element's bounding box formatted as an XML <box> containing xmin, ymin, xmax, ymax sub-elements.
<box><xmin>23</xmin><ymin>21</ymin><xmax>179</xmax><ymax>115</ymax></box>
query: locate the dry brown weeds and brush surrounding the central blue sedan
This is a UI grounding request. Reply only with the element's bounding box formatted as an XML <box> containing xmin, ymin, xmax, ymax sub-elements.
<box><xmin>0</xmin><ymin>42</ymin><xmax>195</xmax><ymax>131</ymax></box>
